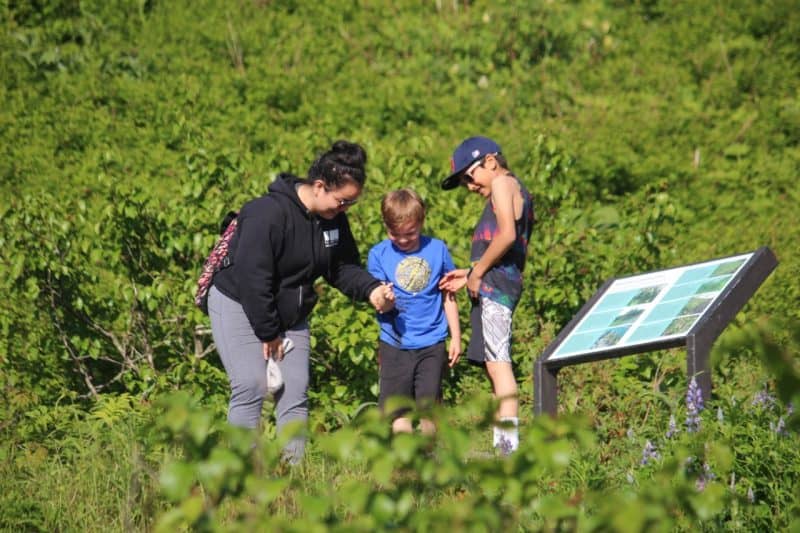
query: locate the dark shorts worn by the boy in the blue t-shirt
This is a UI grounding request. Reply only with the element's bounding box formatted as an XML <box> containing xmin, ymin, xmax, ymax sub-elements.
<box><xmin>378</xmin><ymin>341</ymin><xmax>447</xmax><ymax>418</ymax></box>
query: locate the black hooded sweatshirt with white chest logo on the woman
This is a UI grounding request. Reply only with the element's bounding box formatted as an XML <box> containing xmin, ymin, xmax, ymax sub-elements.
<box><xmin>214</xmin><ymin>174</ymin><xmax>380</xmax><ymax>341</ymax></box>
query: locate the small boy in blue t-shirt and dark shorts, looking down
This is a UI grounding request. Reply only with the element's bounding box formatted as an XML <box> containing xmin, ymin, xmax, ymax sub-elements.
<box><xmin>367</xmin><ymin>189</ymin><xmax>461</xmax><ymax>434</ymax></box>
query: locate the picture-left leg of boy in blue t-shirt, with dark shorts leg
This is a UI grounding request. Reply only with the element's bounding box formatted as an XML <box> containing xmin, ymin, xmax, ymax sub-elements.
<box><xmin>378</xmin><ymin>341</ymin><xmax>414</xmax><ymax>433</ymax></box>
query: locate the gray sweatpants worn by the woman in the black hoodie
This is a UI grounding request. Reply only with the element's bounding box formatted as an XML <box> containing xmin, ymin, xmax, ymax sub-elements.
<box><xmin>208</xmin><ymin>286</ymin><xmax>311</xmax><ymax>462</ymax></box>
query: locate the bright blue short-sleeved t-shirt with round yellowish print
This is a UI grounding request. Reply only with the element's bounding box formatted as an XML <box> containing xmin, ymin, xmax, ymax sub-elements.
<box><xmin>367</xmin><ymin>235</ymin><xmax>455</xmax><ymax>350</ymax></box>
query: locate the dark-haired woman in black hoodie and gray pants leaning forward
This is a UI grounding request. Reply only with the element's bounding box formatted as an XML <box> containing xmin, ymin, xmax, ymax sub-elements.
<box><xmin>208</xmin><ymin>141</ymin><xmax>394</xmax><ymax>462</ymax></box>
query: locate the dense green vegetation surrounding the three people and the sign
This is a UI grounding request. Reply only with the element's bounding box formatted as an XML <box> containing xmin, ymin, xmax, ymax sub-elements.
<box><xmin>0</xmin><ymin>0</ymin><xmax>800</xmax><ymax>531</ymax></box>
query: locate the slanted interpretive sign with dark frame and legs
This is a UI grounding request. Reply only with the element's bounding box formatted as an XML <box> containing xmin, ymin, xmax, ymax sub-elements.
<box><xmin>534</xmin><ymin>247</ymin><xmax>777</xmax><ymax>414</ymax></box>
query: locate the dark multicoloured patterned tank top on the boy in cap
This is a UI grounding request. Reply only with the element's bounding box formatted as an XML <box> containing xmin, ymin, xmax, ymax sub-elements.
<box><xmin>470</xmin><ymin>175</ymin><xmax>536</xmax><ymax>310</ymax></box>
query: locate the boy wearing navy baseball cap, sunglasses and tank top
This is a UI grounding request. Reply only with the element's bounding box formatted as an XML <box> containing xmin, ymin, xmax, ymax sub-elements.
<box><xmin>439</xmin><ymin>137</ymin><xmax>535</xmax><ymax>454</ymax></box>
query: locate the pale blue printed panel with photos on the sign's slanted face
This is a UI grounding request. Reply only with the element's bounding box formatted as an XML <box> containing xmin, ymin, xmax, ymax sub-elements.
<box><xmin>548</xmin><ymin>253</ymin><xmax>753</xmax><ymax>360</ymax></box>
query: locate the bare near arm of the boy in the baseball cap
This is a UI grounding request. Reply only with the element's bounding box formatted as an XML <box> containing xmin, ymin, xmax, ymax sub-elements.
<box><xmin>467</xmin><ymin>176</ymin><xmax>518</xmax><ymax>296</ymax></box>
